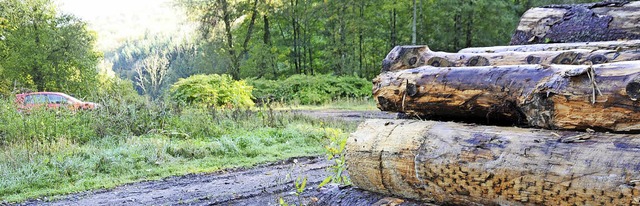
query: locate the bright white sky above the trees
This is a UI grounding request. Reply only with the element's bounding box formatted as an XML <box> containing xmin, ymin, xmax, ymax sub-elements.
<box><xmin>54</xmin><ymin>0</ymin><xmax>189</xmax><ymax>50</ymax></box>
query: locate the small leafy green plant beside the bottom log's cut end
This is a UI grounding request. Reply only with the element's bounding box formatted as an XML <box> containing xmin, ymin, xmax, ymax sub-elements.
<box><xmin>318</xmin><ymin>128</ymin><xmax>351</xmax><ymax>187</ymax></box>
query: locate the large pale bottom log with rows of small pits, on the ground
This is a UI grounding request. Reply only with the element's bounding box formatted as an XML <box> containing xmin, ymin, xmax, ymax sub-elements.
<box><xmin>346</xmin><ymin>120</ymin><xmax>640</xmax><ymax>206</ymax></box>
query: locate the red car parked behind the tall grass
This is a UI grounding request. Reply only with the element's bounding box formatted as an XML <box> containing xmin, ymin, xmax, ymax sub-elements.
<box><xmin>16</xmin><ymin>92</ymin><xmax>100</xmax><ymax>111</ymax></box>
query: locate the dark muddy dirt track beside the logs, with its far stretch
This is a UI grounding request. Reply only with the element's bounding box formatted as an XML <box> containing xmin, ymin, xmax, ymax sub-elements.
<box><xmin>12</xmin><ymin>110</ymin><xmax>426</xmax><ymax>205</ymax></box>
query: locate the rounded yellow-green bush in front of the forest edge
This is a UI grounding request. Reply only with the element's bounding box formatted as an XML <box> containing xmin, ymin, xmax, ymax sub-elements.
<box><xmin>171</xmin><ymin>74</ymin><xmax>254</xmax><ymax>108</ymax></box>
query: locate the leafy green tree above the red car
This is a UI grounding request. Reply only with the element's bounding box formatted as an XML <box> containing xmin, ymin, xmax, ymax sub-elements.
<box><xmin>0</xmin><ymin>0</ymin><xmax>100</xmax><ymax>95</ymax></box>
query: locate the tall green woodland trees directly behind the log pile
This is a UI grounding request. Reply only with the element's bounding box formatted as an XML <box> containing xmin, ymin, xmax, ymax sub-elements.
<box><xmin>171</xmin><ymin>0</ymin><xmax>599</xmax><ymax>82</ymax></box>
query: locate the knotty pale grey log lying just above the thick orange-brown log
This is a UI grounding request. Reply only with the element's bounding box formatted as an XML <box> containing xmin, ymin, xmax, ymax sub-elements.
<box><xmin>382</xmin><ymin>46</ymin><xmax>640</xmax><ymax>72</ymax></box>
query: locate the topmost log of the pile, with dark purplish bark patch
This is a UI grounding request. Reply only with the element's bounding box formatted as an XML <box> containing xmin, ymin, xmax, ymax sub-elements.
<box><xmin>511</xmin><ymin>1</ymin><xmax>640</xmax><ymax>45</ymax></box>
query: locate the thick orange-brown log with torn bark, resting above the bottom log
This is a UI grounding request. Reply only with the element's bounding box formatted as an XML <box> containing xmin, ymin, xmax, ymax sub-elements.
<box><xmin>373</xmin><ymin>61</ymin><xmax>640</xmax><ymax>131</ymax></box>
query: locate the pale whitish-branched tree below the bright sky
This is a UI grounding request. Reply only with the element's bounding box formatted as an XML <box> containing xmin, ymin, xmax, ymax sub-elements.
<box><xmin>105</xmin><ymin>34</ymin><xmax>198</xmax><ymax>99</ymax></box>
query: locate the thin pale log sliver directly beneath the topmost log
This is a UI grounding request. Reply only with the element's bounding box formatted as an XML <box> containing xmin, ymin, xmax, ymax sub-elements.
<box><xmin>458</xmin><ymin>40</ymin><xmax>640</xmax><ymax>53</ymax></box>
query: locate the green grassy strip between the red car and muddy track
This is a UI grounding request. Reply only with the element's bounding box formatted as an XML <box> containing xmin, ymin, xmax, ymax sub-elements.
<box><xmin>0</xmin><ymin>100</ymin><xmax>356</xmax><ymax>202</ymax></box>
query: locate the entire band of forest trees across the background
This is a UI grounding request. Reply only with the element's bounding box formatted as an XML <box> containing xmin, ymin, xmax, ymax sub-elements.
<box><xmin>0</xmin><ymin>0</ymin><xmax>604</xmax><ymax>99</ymax></box>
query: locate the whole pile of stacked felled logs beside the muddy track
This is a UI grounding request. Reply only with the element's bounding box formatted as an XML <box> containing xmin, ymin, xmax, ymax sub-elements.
<box><xmin>346</xmin><ymin>2</ymin><xmax>640</xmax><ymax>205</ymax></box>
